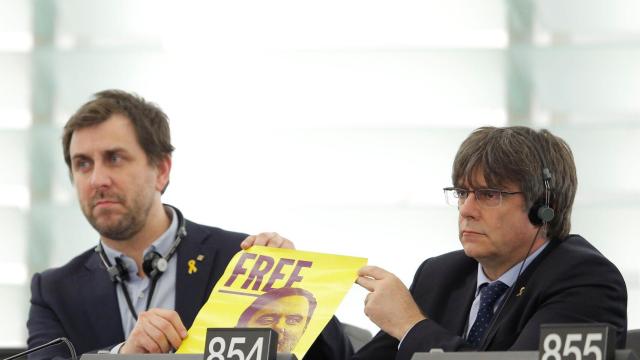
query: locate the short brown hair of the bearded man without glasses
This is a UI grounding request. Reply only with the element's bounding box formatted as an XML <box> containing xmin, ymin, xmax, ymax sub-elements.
<box><xmin>62</xmin><ymin>90</ymin><xmax>174</xmax><ymax>171</ymax></box>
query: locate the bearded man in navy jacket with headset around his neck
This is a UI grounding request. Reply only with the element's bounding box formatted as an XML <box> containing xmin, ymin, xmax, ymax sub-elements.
<box><xmin>27</xmin><ymin>90</ymin><xmax>351</xmax><ymax>359</ymax></box>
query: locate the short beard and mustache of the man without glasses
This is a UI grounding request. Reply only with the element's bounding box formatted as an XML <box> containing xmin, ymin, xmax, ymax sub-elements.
<box><xmin>82</xmin><ymin>191</ymin><xmax>152</xmax><ymax>241</ymax></box>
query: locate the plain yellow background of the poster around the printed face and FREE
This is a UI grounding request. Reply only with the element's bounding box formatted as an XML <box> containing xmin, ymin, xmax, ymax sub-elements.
<box><xmin>177</xmin><ymin>246</ymin><xmax>367</xmax><ymax>359</ymax></box>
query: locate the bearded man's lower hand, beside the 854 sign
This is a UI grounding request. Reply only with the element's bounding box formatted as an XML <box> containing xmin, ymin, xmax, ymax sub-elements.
<box><xmin>120</xmin><ymin>308</ymin><xmax>187</xmax><ymax>354</ymax></box>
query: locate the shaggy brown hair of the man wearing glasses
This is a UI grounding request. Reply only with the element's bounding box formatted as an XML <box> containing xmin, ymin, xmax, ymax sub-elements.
<box><xmin>451</xmin><ymin>126</ymin><xmax>578</xmax><ymax>239</ymax></box>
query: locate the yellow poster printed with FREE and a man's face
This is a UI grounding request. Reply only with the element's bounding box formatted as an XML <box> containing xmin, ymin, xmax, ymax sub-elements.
<box><xmin>177</xmin><ymin>246</ymin><xmax>367</xmax><ymax>359</ymax></box>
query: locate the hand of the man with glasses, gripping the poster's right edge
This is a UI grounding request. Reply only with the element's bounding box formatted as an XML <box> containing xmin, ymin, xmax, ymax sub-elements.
<box><xmin>356</xmin><ymin>266</ymin><xmax>426</xmax><ymax>340</ymax></box>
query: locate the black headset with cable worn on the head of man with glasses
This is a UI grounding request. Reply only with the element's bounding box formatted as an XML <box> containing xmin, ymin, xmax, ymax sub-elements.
<box><xmin>478</xmin><ymin>131</ymin><xmax>555</xmax><ymax>349</ymax></box>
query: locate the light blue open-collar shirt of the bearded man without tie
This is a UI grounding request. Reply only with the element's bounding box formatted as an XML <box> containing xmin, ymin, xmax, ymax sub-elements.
<box><xmin>102</xmin><ymin>206</ymin><xmax>178</xmax><ymax>338</ymax></box>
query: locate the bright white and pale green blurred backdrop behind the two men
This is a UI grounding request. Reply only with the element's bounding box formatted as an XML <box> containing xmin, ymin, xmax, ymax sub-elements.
<box><xmin>0</xmin><ymin>0</ymin><xmax>640</xmax><ymax>346</ymax></box>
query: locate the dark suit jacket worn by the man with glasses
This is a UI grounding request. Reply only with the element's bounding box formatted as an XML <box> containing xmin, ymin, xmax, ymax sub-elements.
<box><xmin>355</xmin><ymin>235</ymin><xmax>627</xmax><ymax>360</ymax></box>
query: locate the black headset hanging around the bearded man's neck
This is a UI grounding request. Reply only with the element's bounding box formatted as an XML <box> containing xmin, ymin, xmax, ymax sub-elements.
<box><xmin>95</xmin><ymin>205</ymin><xmax>187</xmax><ymax>320</ymax></box>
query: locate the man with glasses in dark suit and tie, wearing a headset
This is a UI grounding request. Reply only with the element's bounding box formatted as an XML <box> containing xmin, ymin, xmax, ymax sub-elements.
<box><xmin>355</xmin><ymin>127</ymin><xmax>627</xmax><ymax>359</ymax></box>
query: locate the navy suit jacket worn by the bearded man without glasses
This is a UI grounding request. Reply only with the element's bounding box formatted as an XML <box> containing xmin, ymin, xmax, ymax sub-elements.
<box><xmin>27</xmin><ymin>221</ymin><xmax>352</xmax><ymax>359</ymax></box>
